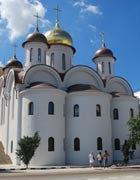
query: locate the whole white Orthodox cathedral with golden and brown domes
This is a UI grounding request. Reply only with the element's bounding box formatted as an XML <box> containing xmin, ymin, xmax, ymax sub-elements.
<box><xmin>0</xmin><ymin>10</ymin><xmax>140</xmax><ymax>166</ymax></box>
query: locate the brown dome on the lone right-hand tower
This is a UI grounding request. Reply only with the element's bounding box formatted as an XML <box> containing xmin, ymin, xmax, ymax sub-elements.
<box><xmin>93</xmin><ymin>43</ymin><xmax>116</xmax><ymax>60</ymax></box>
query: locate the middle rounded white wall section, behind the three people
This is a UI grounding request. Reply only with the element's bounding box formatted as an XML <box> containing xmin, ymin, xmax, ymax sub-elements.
<box><xmin>66</xmin><ymin>91</ymin><xmax>112</xmax><ymax>165</ymax></box>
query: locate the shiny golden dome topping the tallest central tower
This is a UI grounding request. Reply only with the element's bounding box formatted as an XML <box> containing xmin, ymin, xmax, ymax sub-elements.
<box><xmin>45</xmin><ymin>21</ymin><xmax>73</xmax><ymax>46</ymax></box>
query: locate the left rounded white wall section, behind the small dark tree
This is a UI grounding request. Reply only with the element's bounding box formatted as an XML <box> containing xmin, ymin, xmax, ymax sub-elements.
<box><xmin>21</xmin><ymin>88</ymin><xmax>66</xmax><ymax>165</ymax></box>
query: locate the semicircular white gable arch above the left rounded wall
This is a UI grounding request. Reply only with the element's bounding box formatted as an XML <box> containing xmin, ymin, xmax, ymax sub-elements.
<box><xmin>23</xmin><ymin>65</ymin><xmax>61</xmax><ymax>87</ymax></box>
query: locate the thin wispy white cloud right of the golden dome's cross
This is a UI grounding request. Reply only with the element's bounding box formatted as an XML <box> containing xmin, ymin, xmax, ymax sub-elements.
<box><xmin>73</xmin><ymin>0</ymin><xmax>102</xmax><ymax>15</ymax></box>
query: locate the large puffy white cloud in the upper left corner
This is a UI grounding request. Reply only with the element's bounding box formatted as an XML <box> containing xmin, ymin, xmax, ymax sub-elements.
<box><xmin>0</xmin><ymin>0</ymin><xmax>46</xmax><ymax>41</ymax></box>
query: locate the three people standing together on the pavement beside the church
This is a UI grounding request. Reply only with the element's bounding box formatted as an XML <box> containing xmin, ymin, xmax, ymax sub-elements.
<box><xmin>89</xmin><ymin>150</ymin><xmax>109</xmax><ymax>168</ymax></box>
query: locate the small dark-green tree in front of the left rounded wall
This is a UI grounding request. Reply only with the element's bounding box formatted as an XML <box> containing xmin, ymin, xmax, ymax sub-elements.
<box><xmin>16</xmin><ymin>132</ymin><xmax>41</xmax><ymax>169</ymax></box>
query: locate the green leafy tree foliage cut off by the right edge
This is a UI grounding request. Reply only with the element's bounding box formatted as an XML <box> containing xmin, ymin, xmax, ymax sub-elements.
<box><xmin>127</xmin><ymin>116</ymin><xmax>140</xmax><ymax>146</ymax></box>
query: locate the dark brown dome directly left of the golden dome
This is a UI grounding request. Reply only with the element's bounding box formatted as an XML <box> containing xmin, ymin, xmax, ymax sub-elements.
<box><xmin>22</xmin><ymin>29</ymin><xmax>48</xmax><ymax>47</ymax></box>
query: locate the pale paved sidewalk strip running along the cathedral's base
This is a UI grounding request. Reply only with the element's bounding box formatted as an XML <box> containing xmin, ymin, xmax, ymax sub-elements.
<box><xmin>0</xmin><ymin>165</ymin><xmax>140</xmax><ymax>174</ymax></box>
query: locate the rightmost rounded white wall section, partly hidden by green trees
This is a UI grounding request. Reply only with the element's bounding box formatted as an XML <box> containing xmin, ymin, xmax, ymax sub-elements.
<box><xmin>111</xmin><ymin>96</ymin><xmax>140</xmax><ymax>160</ymax></box>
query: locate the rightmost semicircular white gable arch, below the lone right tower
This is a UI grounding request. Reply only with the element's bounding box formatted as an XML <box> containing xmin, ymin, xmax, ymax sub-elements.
<box><xmin>106</xmin><ymin>77</ymin><xmax>133</xmax><ymax>96</ymax></box>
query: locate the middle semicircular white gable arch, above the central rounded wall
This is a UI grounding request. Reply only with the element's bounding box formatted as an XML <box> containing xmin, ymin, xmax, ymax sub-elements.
<box><xmin>64</xmin><ymin>66</ymin><xmax>104</xmax><ymax>90</ymax></box>
